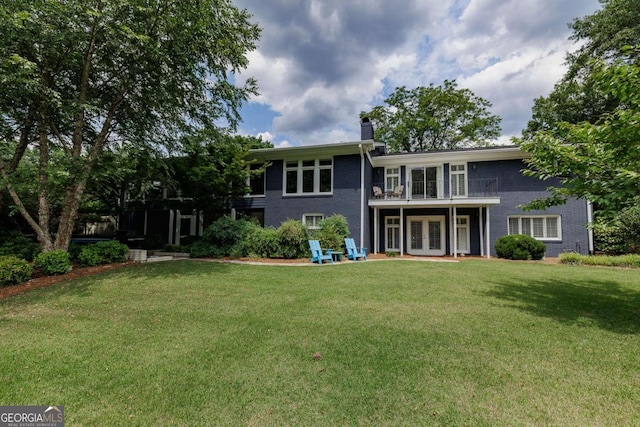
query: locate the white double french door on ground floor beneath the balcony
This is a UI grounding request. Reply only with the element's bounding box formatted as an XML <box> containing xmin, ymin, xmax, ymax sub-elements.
<box><xmin>407</xmin><ymin>216</ymin><xmax>446</xmax><ymax>256</ymax></box>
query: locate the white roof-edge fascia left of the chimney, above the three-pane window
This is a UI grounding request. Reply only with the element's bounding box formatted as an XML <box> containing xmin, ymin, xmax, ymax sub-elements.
<box><xmin>247</xmin><ymin>140</ymin><xmax>384</xmax><ymax>161</ymax></box>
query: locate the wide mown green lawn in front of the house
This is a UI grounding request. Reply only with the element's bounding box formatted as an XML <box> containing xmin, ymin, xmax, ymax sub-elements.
<box><xmin>0</xmin><ymin>260</ymin><xmax>640</xmax><ymax>426</ymax></box>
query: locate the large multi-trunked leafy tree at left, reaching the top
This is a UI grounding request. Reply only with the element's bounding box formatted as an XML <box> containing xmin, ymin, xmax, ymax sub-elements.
<box><xmin>0</xmin><ymin>0</ymin><xmax>259</xmax><ymax>251</ymax></box>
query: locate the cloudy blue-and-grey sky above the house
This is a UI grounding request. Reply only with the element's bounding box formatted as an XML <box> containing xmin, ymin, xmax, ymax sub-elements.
<box><xmin>234</xmin><ymin>0</ymin><xmax>600</xmax><ymax>147</ymax></box>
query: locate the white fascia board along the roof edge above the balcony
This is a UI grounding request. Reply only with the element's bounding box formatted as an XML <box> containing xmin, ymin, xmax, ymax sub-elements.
<box><xmin>372</xmin><ymin>146</ymin><xmax>530</xmax><ymax>167</ymax></box>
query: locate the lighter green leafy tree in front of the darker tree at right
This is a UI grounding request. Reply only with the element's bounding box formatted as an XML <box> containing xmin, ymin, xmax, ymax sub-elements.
<box><xmin>518</xmin><ymin>49</ymin><xmax>640</xmax><ymax>218</ymax></box>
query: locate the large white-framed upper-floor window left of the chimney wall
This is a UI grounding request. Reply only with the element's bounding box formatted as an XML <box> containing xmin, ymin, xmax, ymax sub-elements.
<box><xmin>284</xmin><ymin>159</ymin><xmax>333</xmax><ymax>195</ymax></box>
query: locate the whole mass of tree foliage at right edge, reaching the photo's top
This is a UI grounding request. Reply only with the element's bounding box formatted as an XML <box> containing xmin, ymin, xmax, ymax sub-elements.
<box><xmin>516</xmin><ymin>0</ymin><xmax>640</xmax><ymax>219</ymax></box>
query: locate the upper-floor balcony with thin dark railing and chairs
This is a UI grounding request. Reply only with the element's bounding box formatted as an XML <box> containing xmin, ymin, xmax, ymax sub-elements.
<box><xmin>370</xmin><ymin>178</ymin><xmax>498</xmax><ymax>201</ymax></box>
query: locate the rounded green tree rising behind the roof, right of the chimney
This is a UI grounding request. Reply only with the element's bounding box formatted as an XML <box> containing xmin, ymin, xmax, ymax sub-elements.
<box><xmin>360</xmin><ymin>80</ymin><xmax>501</xmax><ymax>152</ymax></box>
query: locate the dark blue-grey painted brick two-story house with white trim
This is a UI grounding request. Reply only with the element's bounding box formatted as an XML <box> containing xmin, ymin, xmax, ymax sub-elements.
<box><xmin>235</xmin><ymin>119</ymin><xmax>593</xmax><ymax>257</ymax></box>
